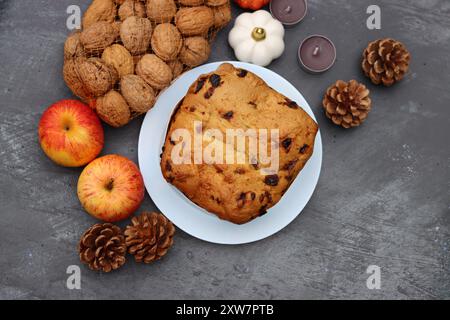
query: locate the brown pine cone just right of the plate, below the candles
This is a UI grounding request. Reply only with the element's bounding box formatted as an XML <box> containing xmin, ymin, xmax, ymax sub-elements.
<box><xmin>322</xmin><ymin>80</ymin><xmax>371</xmax><ymax>128</ymax></box>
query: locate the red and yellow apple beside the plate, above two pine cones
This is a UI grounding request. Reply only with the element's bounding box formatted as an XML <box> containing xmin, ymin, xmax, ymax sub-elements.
<box><xmin>78</xmin><ymin>155</ymin><xmax>144</xmax><ymax>222</ymax></box>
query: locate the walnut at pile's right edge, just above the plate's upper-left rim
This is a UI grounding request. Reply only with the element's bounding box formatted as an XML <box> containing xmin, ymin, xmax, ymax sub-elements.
<box><xmin>180</xmin><ymin>37</ymin><xmax>211</xmax><ymax>67</ymax></box>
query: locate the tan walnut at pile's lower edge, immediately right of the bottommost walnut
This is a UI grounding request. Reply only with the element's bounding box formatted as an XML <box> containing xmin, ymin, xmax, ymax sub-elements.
<box><xmin>120</xmin><ymin>74</ymin><xmax>155</xmax><ymax>113</ymax></box>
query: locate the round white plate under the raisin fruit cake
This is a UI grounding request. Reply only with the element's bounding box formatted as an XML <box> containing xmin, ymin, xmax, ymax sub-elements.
<box><xmin>138</xmin><ymin>62</ymin><xmax>322</xmax><ymax>244</ymax></box>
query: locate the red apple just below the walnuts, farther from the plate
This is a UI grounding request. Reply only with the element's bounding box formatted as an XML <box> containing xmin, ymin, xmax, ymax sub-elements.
<box><xmin>39</xmin><ymin>100</ymin><xmax>104</xmax><ymax>167</ymax></box>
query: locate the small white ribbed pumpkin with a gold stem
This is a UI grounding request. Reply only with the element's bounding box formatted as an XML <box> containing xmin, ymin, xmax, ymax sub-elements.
<box><xmin>228</xmin><ymin>10</ymin><xmax>285</xmax><ymax>67</ymax></box>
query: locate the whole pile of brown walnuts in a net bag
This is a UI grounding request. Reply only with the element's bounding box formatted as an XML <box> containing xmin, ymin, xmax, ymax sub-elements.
<box><xmin>63</xmin><ymin>0</ymin><xmax>231</xmax><ymax>127</ymax></box>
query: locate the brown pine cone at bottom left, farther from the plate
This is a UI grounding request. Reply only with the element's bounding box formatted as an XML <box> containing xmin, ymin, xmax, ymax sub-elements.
<box><xmin>78</xmin><ymin>223</ymin><xmax>127</xmax><ymax>272</ymax></box>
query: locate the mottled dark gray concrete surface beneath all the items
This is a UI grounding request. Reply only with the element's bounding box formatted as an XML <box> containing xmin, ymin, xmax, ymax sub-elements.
<box><xmin>0</xmin><ymin>0</ymin><xmax>450</xmax><ymax>299</ymax></box>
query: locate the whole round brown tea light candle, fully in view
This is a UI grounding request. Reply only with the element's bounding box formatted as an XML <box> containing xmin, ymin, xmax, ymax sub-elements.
<box><xmin>298</xmin><ymin>35</ymin><xmax>336</xmax><ymax>74</ymax></box>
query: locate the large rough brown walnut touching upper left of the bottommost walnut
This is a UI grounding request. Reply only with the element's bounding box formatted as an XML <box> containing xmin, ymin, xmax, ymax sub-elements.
<box><xmin>77</xmin><ymin>58</ymin><xmax>119</xmax><ymax>97</ymax></box>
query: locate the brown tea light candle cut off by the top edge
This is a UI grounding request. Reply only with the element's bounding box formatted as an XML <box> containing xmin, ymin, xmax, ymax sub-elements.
<box><xmin>270</xmin><ymin>0</ymin><xmax>308</xmax><ymax>26</ymax></box>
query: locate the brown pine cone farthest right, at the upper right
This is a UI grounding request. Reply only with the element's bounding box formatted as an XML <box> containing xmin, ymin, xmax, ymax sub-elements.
<box><xmin>362</xmin><ymin>38</ymin><xmax>411</xmax><ymax>87</ymax></box>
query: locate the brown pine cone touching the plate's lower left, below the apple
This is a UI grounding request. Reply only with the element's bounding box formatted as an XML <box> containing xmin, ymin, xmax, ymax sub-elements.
<box><xmin>125</xmin><ymin>212</ymin><xmax>175</xmax><ymax>263</ymax></box>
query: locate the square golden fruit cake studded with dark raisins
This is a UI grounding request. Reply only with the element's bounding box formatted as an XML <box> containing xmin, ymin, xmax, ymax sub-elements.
<box><xmin>161</xmin><ymin>63</ymin><xmax>318</xmax><ymax>224</ymax></box>
